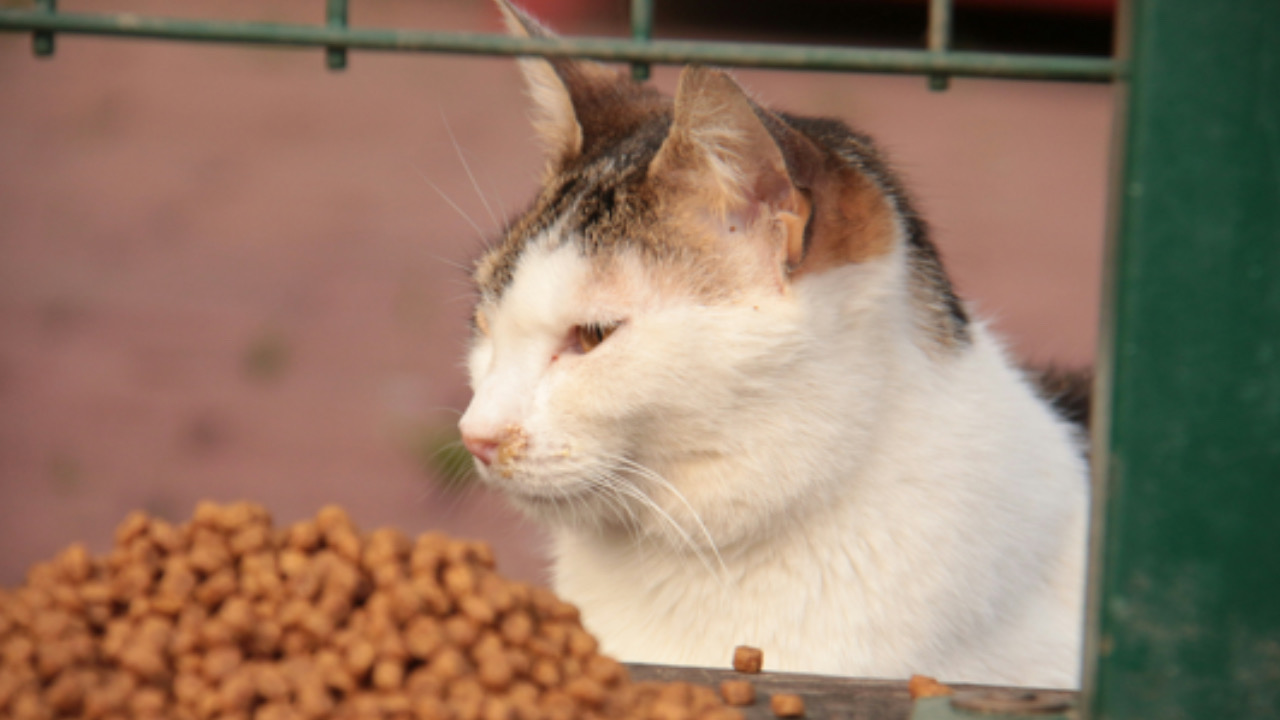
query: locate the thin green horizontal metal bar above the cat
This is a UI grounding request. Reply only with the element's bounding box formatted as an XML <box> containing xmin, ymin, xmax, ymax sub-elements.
<box><xmin>0</xmin><ymin>10</ymin><xmax>1123</xmax><ymax>82</ymax></box>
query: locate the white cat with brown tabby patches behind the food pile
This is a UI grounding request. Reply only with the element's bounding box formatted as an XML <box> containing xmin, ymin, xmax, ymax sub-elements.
<box><xmin>460</xmin><ymin>0</ymin><xmax>1088</xmax><ymax>687</ymax></box>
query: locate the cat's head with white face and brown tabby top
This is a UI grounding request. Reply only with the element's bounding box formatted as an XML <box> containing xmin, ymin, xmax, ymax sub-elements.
<box><xmin>460</xmin><ymin>3</ymin><xmax>964</xmax><ymax>543</ymax></box>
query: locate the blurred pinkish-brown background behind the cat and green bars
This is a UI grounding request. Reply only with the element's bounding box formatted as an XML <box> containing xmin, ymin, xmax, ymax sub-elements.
<box><xmin>0</xmin><ymin>0</ymin><xmax>1112</xmax><ymax>585</ymax></box>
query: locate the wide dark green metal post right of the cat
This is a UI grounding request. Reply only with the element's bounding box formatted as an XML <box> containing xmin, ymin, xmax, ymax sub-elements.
<box><xmin>1084</xmin><ymin>0</ymin><xmax>1280</xmax><ymax>720</ymax></box>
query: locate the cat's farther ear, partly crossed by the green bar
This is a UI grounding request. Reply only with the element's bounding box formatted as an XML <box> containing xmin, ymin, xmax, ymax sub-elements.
<box><xmin>495</xmin><ymin>0</ymin><xmax>655</xmax><ymax>164</ymax></box>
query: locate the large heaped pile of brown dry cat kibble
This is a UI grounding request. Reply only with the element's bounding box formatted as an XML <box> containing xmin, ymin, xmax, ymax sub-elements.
<box><xmin>0</xmin><ymin>502</ymin><xmax>742</xmax><ymax>720</ymax></box>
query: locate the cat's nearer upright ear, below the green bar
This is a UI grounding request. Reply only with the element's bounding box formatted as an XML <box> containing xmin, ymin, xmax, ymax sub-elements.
<box><xmin>649</xmin><ymin>65</ymin><xmax>815</xmax><ymax>266</ymax></box>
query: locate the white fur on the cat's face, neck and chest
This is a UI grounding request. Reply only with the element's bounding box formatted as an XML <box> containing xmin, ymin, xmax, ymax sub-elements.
<box><xmin>462</xmin><ymin>228</ymin><xmax>1087</xmax><ymax>687</ymax></box>
